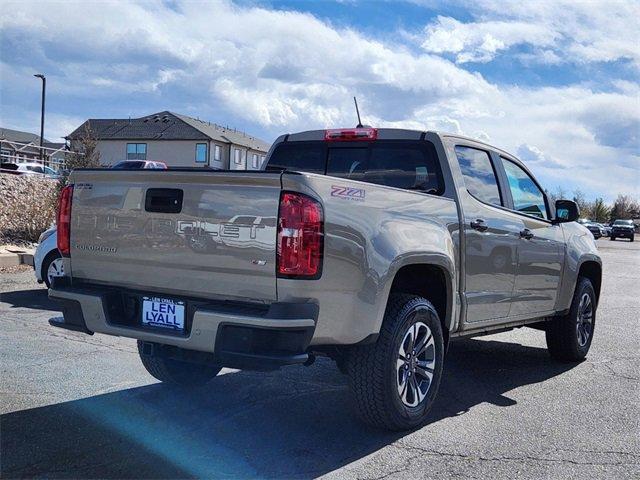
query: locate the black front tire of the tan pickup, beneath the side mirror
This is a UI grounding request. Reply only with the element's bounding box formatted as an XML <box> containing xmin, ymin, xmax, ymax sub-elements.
<box><xmin>546</xmin><ymin>277</ymin><xmax>597</xmax><ymax>362</ymax></box>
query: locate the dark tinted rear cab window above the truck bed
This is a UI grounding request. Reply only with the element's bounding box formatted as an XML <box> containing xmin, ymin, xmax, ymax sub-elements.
<box><xmin>266</xmin><ymin>140</ymin><xmax>444</xmax><ymax>195</ymax></box>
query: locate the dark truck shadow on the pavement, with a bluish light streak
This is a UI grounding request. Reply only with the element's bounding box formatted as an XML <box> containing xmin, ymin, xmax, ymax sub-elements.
<box><xmin>0</xmin><ymin>339</ymin><xmax>571</xmax><ymax>478</ymax></box>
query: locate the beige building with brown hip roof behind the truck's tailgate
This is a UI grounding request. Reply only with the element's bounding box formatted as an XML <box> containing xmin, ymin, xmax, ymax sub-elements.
<box><xmin>66</xmin><ymin>111</ymin><xmax>269</xmax><ymax>170</ymax></box>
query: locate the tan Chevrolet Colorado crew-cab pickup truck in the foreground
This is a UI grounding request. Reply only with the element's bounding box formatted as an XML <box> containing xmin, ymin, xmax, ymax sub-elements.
<box><xmin>49</xmin><ymin>128</ymin><xmax>601</xmax><ymax>430</ymax></box>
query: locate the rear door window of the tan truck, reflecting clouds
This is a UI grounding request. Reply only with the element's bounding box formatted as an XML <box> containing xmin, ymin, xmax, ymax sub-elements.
<box><xmin>456</xmin><ymin>145</ymin><xmax>502</xmax><ymax>205</ymax></box>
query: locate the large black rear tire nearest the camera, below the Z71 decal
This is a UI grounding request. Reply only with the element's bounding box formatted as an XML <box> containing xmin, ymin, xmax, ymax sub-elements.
<box><xmin>347</xmin><ymin>294</ymin><xmax>444</xmax><ymax>431</ymax></box>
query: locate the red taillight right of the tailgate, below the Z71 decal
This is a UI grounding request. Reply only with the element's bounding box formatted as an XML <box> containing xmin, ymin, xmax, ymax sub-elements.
<box><xmin>276</xmin><ymin>192</ymin><xmax>324</xmax><ymax>279</ymax></box>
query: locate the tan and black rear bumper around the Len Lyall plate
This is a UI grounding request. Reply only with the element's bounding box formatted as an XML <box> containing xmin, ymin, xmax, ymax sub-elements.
<box><xmin>49</xmin><ymin>285</ymin><xmax>318</xmax><ymax>369</ymax></box>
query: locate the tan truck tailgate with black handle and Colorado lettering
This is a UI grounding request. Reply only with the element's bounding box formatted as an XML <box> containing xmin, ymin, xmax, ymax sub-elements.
<box><xmin>70</xmin><ymin>170</ymin><xmax>281</xmax><ymax>301</ymax></box>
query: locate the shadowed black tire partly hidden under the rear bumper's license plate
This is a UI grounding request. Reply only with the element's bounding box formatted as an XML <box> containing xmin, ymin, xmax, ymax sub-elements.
<box><xmin>138</xmin><ymin>340</ymin><xmax>221</xmax><ymax>387</ymax></box>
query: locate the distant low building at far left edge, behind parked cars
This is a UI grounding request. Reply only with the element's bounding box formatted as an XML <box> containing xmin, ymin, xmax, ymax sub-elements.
<box><xmin>0</xmin><ymin>128</ymin><xmax>67</xmax><ymax>168</ymax></box>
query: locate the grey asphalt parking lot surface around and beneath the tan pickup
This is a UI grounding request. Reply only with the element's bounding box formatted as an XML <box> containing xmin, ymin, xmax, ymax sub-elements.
<box><xmin>0</xmin><ymin>239</ymin><xmax>640</xmax><ymax>479</ymax></box>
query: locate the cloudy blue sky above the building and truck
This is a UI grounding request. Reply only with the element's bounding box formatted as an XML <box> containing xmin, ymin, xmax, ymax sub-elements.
<box><xmin>0</xmin><ymin>0</ymin><xmax>640</xmax><ymax>200</ymax></box>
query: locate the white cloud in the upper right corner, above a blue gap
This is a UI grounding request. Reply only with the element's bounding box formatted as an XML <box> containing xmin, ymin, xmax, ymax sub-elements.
<box><xmin>422</xmin><ymin>0</ymin><xmax>640</xmax><ymax>68</ymax></box>
